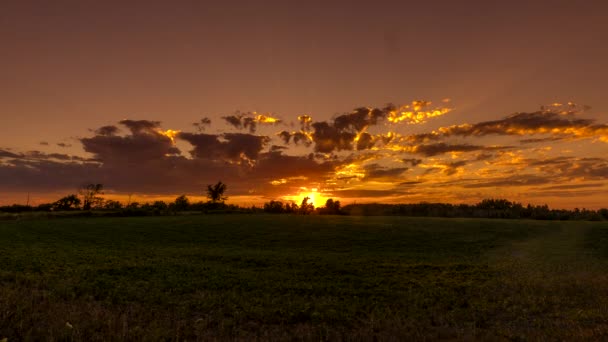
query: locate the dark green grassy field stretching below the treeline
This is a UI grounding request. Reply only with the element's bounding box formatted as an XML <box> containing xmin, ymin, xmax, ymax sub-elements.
<box><xmin>0</xmin><ymin>215</ymin><xmax>608</xmax><ymax>341</ymax></box>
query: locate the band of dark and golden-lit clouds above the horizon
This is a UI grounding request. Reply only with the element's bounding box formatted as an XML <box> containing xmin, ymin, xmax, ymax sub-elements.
<box><xmin>0</xmin><ymin>101</ymin><xmax>608</xmax><ymax>208</ymax></box>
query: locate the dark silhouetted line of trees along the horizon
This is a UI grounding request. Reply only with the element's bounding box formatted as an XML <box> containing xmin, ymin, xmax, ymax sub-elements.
<box><xmin>0</xmin><ymin>181</ymin><xmax>608</xmax><ymax>221</ymax></box>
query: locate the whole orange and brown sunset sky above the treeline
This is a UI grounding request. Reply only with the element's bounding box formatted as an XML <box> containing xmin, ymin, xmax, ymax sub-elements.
<box><xmin>0</xmin><ymin>0</ymin><xmax>608</xmax><ymax>208</ymax></box>
